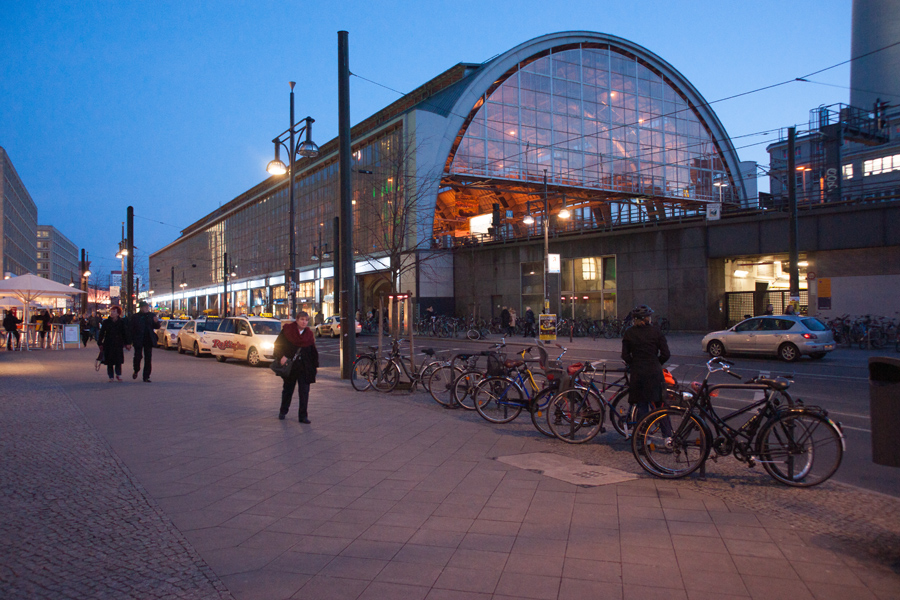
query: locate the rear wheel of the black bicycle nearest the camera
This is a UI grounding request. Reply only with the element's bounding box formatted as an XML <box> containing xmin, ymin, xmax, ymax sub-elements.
<box><xmin>758</xmin><ymin>412</ymin><xmax>844</xmax><ymax>487</ymax></box>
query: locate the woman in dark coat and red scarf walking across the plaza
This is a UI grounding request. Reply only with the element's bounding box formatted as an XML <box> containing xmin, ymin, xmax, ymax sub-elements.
<box><xmin>273</xmin><ymin>310</ymin><xmax>319</xmax><ymax>425</ymax></box>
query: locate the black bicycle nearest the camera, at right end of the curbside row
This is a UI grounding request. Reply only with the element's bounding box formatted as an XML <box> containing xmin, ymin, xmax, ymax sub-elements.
<box><xmin>631</xmin><ymin>358</ymin><xmax>845</xmax><ymax>487</ymax></box>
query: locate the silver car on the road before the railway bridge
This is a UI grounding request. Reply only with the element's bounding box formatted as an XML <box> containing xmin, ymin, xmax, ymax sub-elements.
<box><xmin>701</xmin><ymin>315</ymin><xmax>834</xmax><ymax>362</ymax></box>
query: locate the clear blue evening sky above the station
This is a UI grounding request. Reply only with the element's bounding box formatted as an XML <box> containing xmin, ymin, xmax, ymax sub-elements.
<box><xmin>0</xmin><ymin>0</ymin><xmax>851</xmax><ymax>284</ymax></box>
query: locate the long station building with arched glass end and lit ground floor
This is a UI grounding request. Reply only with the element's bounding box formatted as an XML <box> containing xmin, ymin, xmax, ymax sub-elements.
<box><xmin>150</xmin><ymin>32</ymin><xmax>756</xmax><ymax>328</ymax></box>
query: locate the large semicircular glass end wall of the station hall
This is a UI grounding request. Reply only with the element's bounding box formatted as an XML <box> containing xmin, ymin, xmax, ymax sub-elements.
<box><xmin>436</xmin><ymin>43</ymin><xmax>735</xmax><ymax>235</ymax></box>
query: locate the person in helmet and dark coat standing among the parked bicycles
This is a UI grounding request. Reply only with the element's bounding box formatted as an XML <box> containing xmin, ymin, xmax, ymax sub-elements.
<box><xmin>622</xmin><ymin>304</ymin><xmax>670</xmax><ymax>428</ymax></box>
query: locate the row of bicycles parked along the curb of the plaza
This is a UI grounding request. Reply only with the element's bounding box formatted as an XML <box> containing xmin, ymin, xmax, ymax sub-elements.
<box><xmin>351</xmin><ymin>340</ymin><xmax>845</xmax><ymax>487</ymax></box>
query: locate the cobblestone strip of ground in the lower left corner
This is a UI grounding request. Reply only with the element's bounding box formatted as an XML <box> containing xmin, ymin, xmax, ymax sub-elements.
<box><xmin>0</xmin><ymin>356</ymin><xmax>232</xmax><ymax>600</ymax></box>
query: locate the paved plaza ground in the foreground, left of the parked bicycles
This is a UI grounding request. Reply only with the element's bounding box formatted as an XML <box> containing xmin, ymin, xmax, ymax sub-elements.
<box><xmin>0</xmin><ymin>349</ymin><xmax>900</xmax><ymax>600</ymax></box>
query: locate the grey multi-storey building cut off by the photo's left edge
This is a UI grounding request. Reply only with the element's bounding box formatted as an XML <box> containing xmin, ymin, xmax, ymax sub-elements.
<box><xmin>0</xmin><ymin>147</ymin><xmax>37</xmax><ymax>283</ymax></box>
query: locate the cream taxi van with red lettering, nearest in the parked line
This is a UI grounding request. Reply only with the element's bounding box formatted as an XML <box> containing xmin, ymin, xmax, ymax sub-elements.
<box><xmin>205</xmin><ymin>317</ymin><xmax>281</xmax><ymax>367</ymax></box>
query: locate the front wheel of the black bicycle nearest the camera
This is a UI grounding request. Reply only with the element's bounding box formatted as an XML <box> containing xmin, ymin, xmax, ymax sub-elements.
<box><xmin>631</xmin><ymin>408</ymin><xmax>709</xmax><ymax>479</ymax></box>
